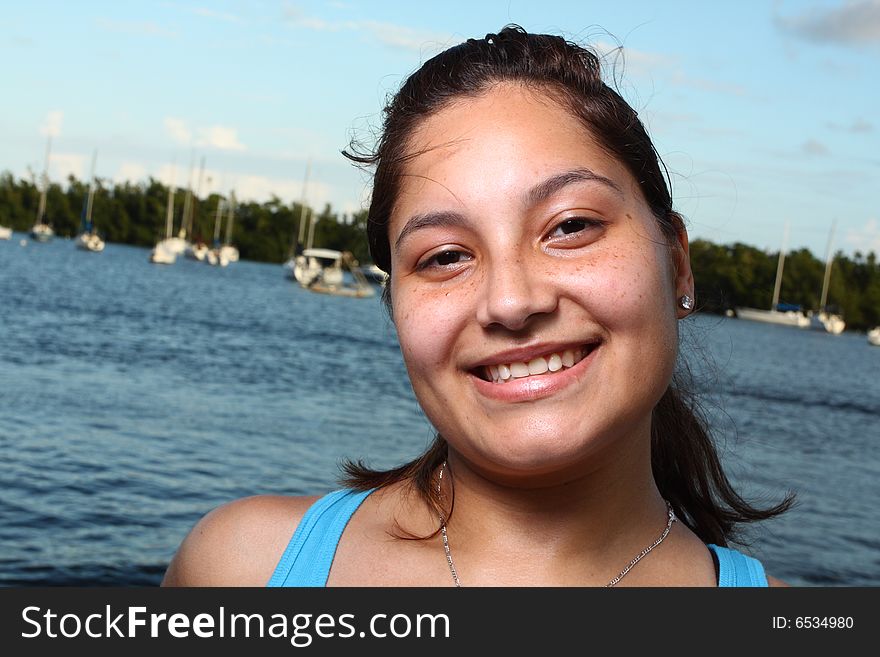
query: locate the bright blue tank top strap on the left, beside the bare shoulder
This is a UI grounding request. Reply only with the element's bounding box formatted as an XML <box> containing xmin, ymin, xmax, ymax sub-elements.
<box><xmin>267</xmin><ymin>489</ymin><xmax>373</xmax><ymax>587</ymax></box>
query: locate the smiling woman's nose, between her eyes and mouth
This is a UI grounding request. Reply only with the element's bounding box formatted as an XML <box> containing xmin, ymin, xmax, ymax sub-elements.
<box><xmin>477</xmin><ymin>258</ymin><xmax>558</xmax><ymax>331</ymax></box>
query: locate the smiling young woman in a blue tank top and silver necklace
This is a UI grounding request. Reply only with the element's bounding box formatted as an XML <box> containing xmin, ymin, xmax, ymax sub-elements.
<box><xmin>164</xmin><ymin>26</ymin><xmax>791</xmax><ymax>586</ymax></box>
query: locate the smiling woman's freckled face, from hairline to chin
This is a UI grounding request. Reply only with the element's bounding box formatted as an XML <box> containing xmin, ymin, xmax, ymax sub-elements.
<box><xmin>389</xmin><ymin>84</ymin><xmax>693</xmax><ymax>476</ymax></box>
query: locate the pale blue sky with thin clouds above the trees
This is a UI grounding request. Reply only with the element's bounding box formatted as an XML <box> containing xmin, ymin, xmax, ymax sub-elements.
<box><xmin>0</xmin><ymin>0</ymin><xmax>880</xmax><ymax>258</ymax></box>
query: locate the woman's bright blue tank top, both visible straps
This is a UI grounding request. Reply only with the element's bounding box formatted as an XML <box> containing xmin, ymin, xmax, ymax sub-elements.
<box><xmin>268</xmin><ymin>489</ymin><xmax>767</xmax><ymax>587</ymax></box>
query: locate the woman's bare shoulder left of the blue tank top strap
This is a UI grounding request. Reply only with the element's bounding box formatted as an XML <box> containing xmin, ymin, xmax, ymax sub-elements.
<box><xmin>162</xmin><ymin>495</ymin><xmax>318</xmax><ymax>586</ymax></box>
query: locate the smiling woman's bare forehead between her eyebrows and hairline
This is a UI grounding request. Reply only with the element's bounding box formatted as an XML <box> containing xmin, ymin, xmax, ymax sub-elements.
<box><xmin>389</xmin><ymin>85</ymin><xmax>640</xmax><ymax>228</ymax></box>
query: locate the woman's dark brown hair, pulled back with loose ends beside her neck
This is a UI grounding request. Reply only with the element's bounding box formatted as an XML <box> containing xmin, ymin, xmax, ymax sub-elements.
<box><xmin>343</xmin><ymin>25</ymin><xmax>794</xmax><ymax>546</ymax></box>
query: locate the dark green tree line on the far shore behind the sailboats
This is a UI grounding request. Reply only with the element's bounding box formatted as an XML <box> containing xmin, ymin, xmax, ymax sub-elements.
<box><xmin>0</xmin><ymin>173</ymin><xmax>880</xmax><ymax>330</ymax></box>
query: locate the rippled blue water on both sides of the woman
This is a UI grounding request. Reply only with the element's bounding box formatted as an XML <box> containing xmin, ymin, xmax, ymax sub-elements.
<box><xmin>0</xmin><ymin>234</ymin><xmax>880</xmax><ymax>586</ymax></box>
